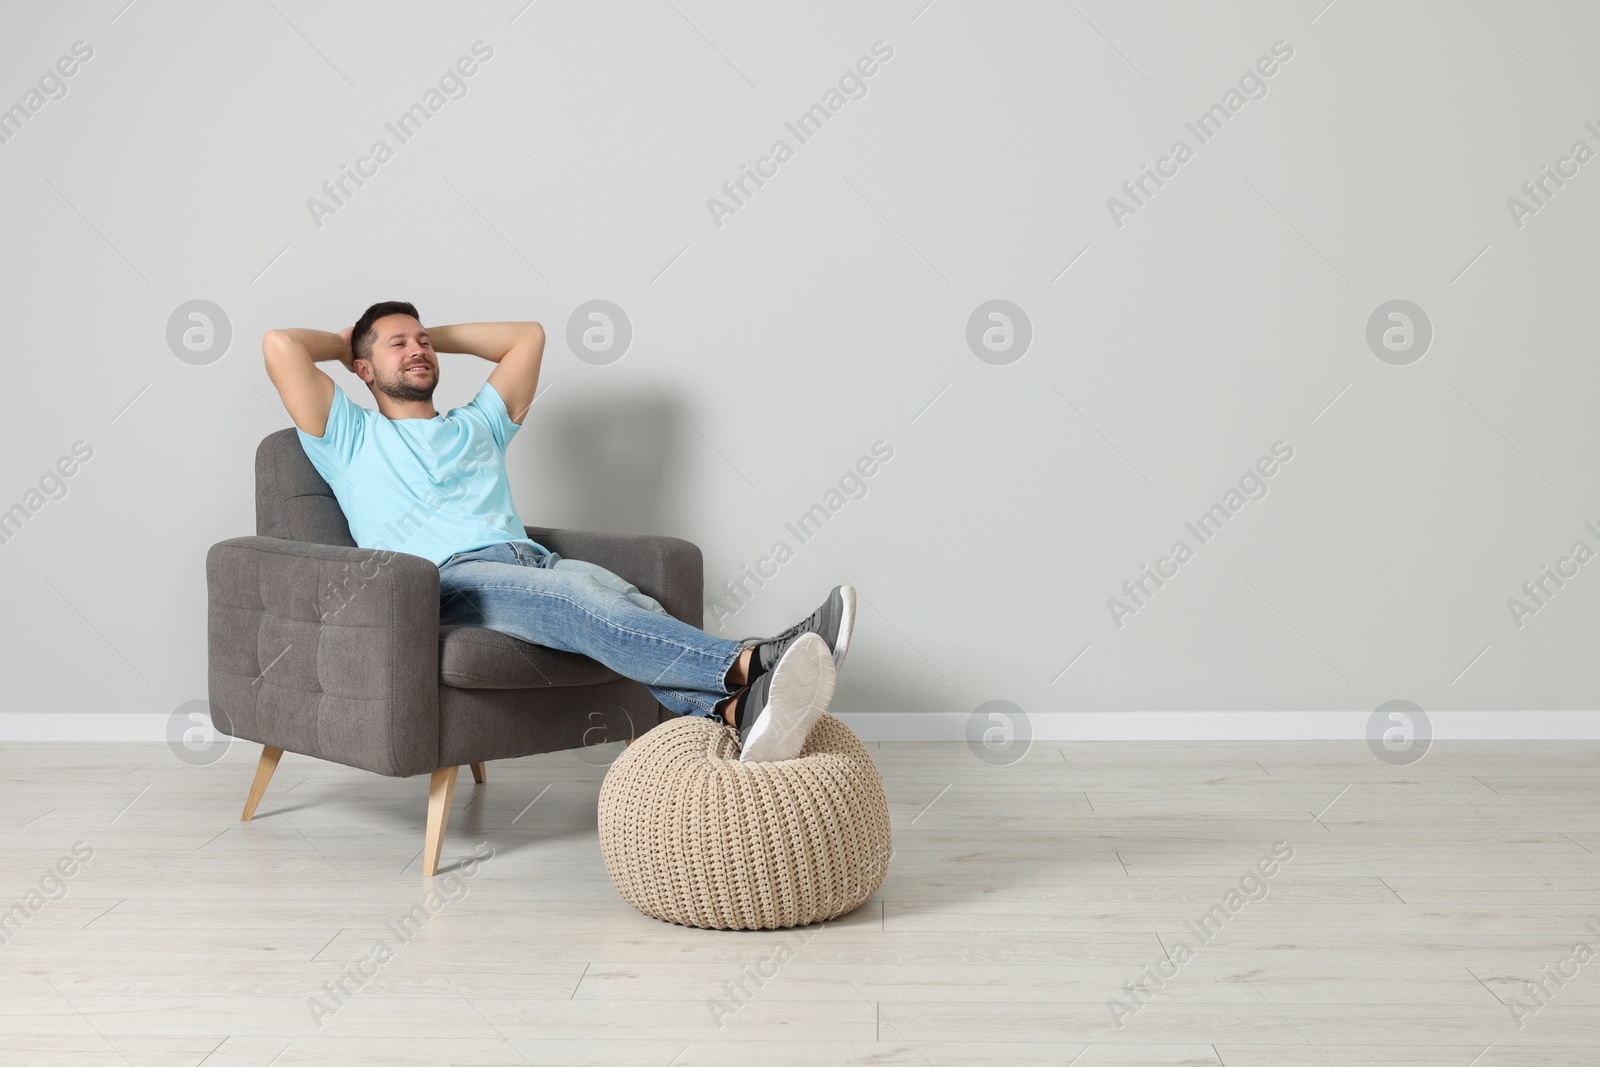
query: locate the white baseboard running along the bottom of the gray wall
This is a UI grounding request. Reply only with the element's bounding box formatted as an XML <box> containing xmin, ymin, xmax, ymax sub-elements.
<box><xmin>0</xmin><ymin>710</ymin><xmax>1600</xmax><ymax>742</ymax></box>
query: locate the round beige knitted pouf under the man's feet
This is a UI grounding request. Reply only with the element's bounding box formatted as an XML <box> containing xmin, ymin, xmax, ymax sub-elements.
<box><xmin>600</xmin><ymin>715</ymin><xmax>890</xmax><ymax>929</ymax></box>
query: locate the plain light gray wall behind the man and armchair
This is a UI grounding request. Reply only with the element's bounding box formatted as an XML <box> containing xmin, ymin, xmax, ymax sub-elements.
<box><xmin>0</xmin><ymin>0</ymin><xmax>1600</xmax><ymax>735</ymax></box>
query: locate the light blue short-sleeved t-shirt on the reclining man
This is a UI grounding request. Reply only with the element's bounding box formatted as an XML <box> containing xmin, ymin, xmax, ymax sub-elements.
<box><xmin>298</xmin><ymin>382</ymin><xmax>542</xmax><ymax>566</ymax></box>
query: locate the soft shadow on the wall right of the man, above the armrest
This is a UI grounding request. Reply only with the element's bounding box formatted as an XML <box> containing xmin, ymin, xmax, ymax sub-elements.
<box><xmin>512</xmin><ymin>390</ymin><xmax>693</xmax><ymax>534</ymax></box>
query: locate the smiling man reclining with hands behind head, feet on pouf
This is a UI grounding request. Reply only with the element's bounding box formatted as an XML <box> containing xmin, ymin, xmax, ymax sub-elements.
<box><xmin>261</xmin><ymin>301</ymin><xmax>856</xmax><ymax>761</ymax></box>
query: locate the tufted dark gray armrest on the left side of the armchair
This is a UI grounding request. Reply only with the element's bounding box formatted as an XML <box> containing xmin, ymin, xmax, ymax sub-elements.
<box><xmin>206</xmin><ymin>537</ymin><xmax>438</xmax><ymax>776</ymax></box>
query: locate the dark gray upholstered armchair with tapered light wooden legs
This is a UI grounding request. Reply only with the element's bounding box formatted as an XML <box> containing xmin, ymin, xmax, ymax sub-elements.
<box><xmin>206</xmin><ymin>429</ymin><xmax>702</xmax><ymax>877</ymax></box>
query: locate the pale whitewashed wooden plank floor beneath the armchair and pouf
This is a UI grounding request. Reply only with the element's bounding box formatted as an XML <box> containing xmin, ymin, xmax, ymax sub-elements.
<box><xmin>0</xmin><ymin>742</ymin><xmax>1600</xmax><ymax>1067</ymax></box>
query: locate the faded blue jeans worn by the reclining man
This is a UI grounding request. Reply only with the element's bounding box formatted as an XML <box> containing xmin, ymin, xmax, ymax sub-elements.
<box><xmin>438</xmin><ymin>541</ymin><xmax>746</xmax><ymax>715</ymax></box>
